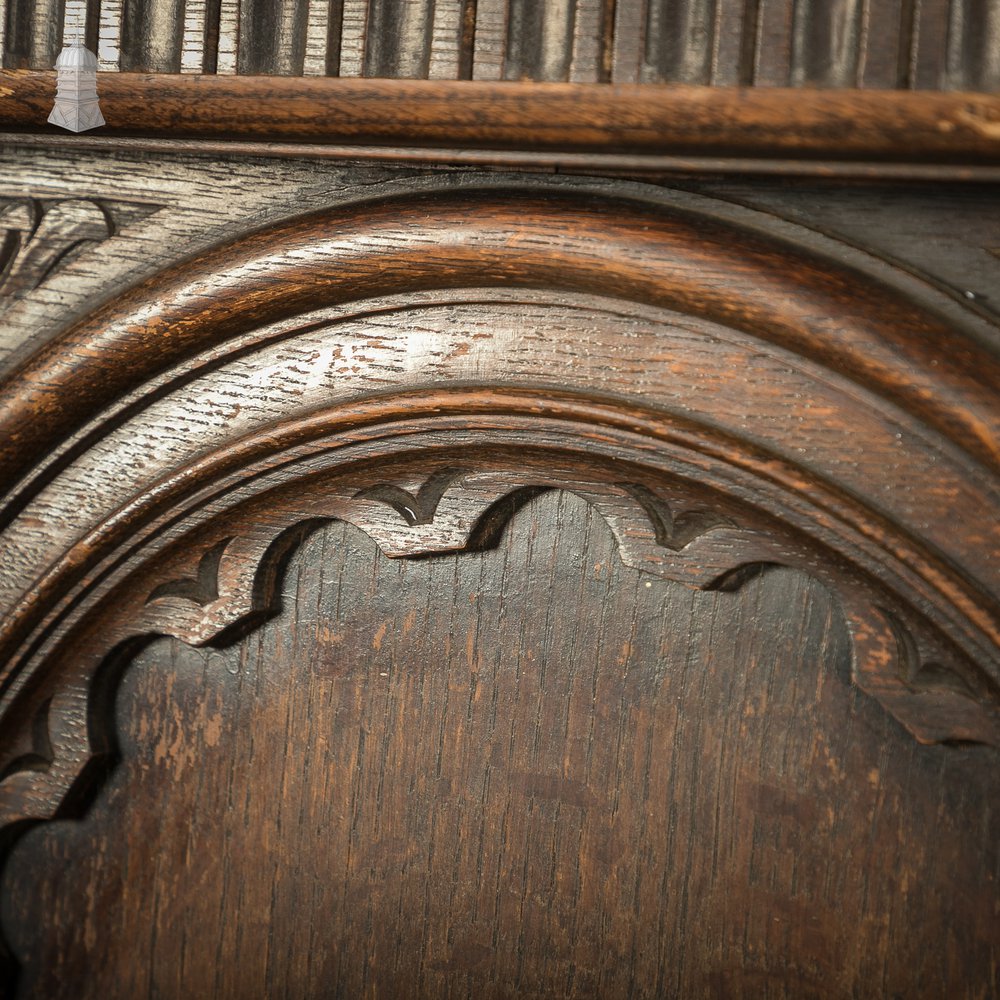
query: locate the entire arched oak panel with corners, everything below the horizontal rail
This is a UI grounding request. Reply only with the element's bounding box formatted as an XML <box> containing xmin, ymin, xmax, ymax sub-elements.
<box><xmin>0</xmin><ymin>145</ymin><xmax>1000</xmax><ymax>998</ymax></box>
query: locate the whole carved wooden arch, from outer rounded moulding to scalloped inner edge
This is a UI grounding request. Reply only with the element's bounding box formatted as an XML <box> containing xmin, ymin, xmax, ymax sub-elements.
<box><xmin>0</xmin><ymin>186</ymin><xmax>1000</xmax><ymax>876</ymax></box>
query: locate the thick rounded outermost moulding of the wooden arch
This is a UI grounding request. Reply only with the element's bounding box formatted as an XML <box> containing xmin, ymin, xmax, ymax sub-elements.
<box><xmin>0</xmin><ymin>186</ymin><xmax>1000</xmax><ymax>494</ymax></box>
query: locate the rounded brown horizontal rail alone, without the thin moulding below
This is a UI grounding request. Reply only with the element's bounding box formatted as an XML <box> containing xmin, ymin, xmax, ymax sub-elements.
<box><xmin>0</xmin><ymin>71</ymin><xmax>1000</xmax><ymax>164</ymax></box>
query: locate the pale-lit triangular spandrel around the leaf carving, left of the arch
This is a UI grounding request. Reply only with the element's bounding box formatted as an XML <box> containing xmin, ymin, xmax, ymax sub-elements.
<box><xmin>0</xmin><ymin>148</ymin><xmax>410</xmax><ymax>378</ymax></box>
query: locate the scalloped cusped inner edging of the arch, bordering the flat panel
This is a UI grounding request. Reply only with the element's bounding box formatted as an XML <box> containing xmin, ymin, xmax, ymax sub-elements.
<box><xmin>0</xmin><ymin>467</ymin><xmax>1000</xmax><ymax>836</ymax></box>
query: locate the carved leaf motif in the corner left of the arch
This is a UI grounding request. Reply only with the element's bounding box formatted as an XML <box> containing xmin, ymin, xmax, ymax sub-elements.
<box><xmin>0</xmin><ymin>198</ymin><xmax>114</xmax><ymax>302</ymax></box>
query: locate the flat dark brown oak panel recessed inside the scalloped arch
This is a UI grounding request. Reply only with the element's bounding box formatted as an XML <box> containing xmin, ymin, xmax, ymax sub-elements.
<box><xmin>3</xmin><ymin>494</ymin><xmax>1000</xmax><ymax>998</ymax></box>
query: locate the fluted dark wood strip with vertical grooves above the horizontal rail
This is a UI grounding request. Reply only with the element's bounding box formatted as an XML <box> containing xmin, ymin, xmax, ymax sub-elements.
<box><xmin>0</xmin><ymin>0</ymin><xmax>1000</xmax><ymax>93</ymax></box>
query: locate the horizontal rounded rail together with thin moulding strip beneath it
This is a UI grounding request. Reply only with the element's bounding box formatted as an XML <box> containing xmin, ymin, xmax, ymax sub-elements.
<box><xmin>0</xmin><ymin>70</ymin><xmax>1000</xmax><ymax>180</ymax></box>
